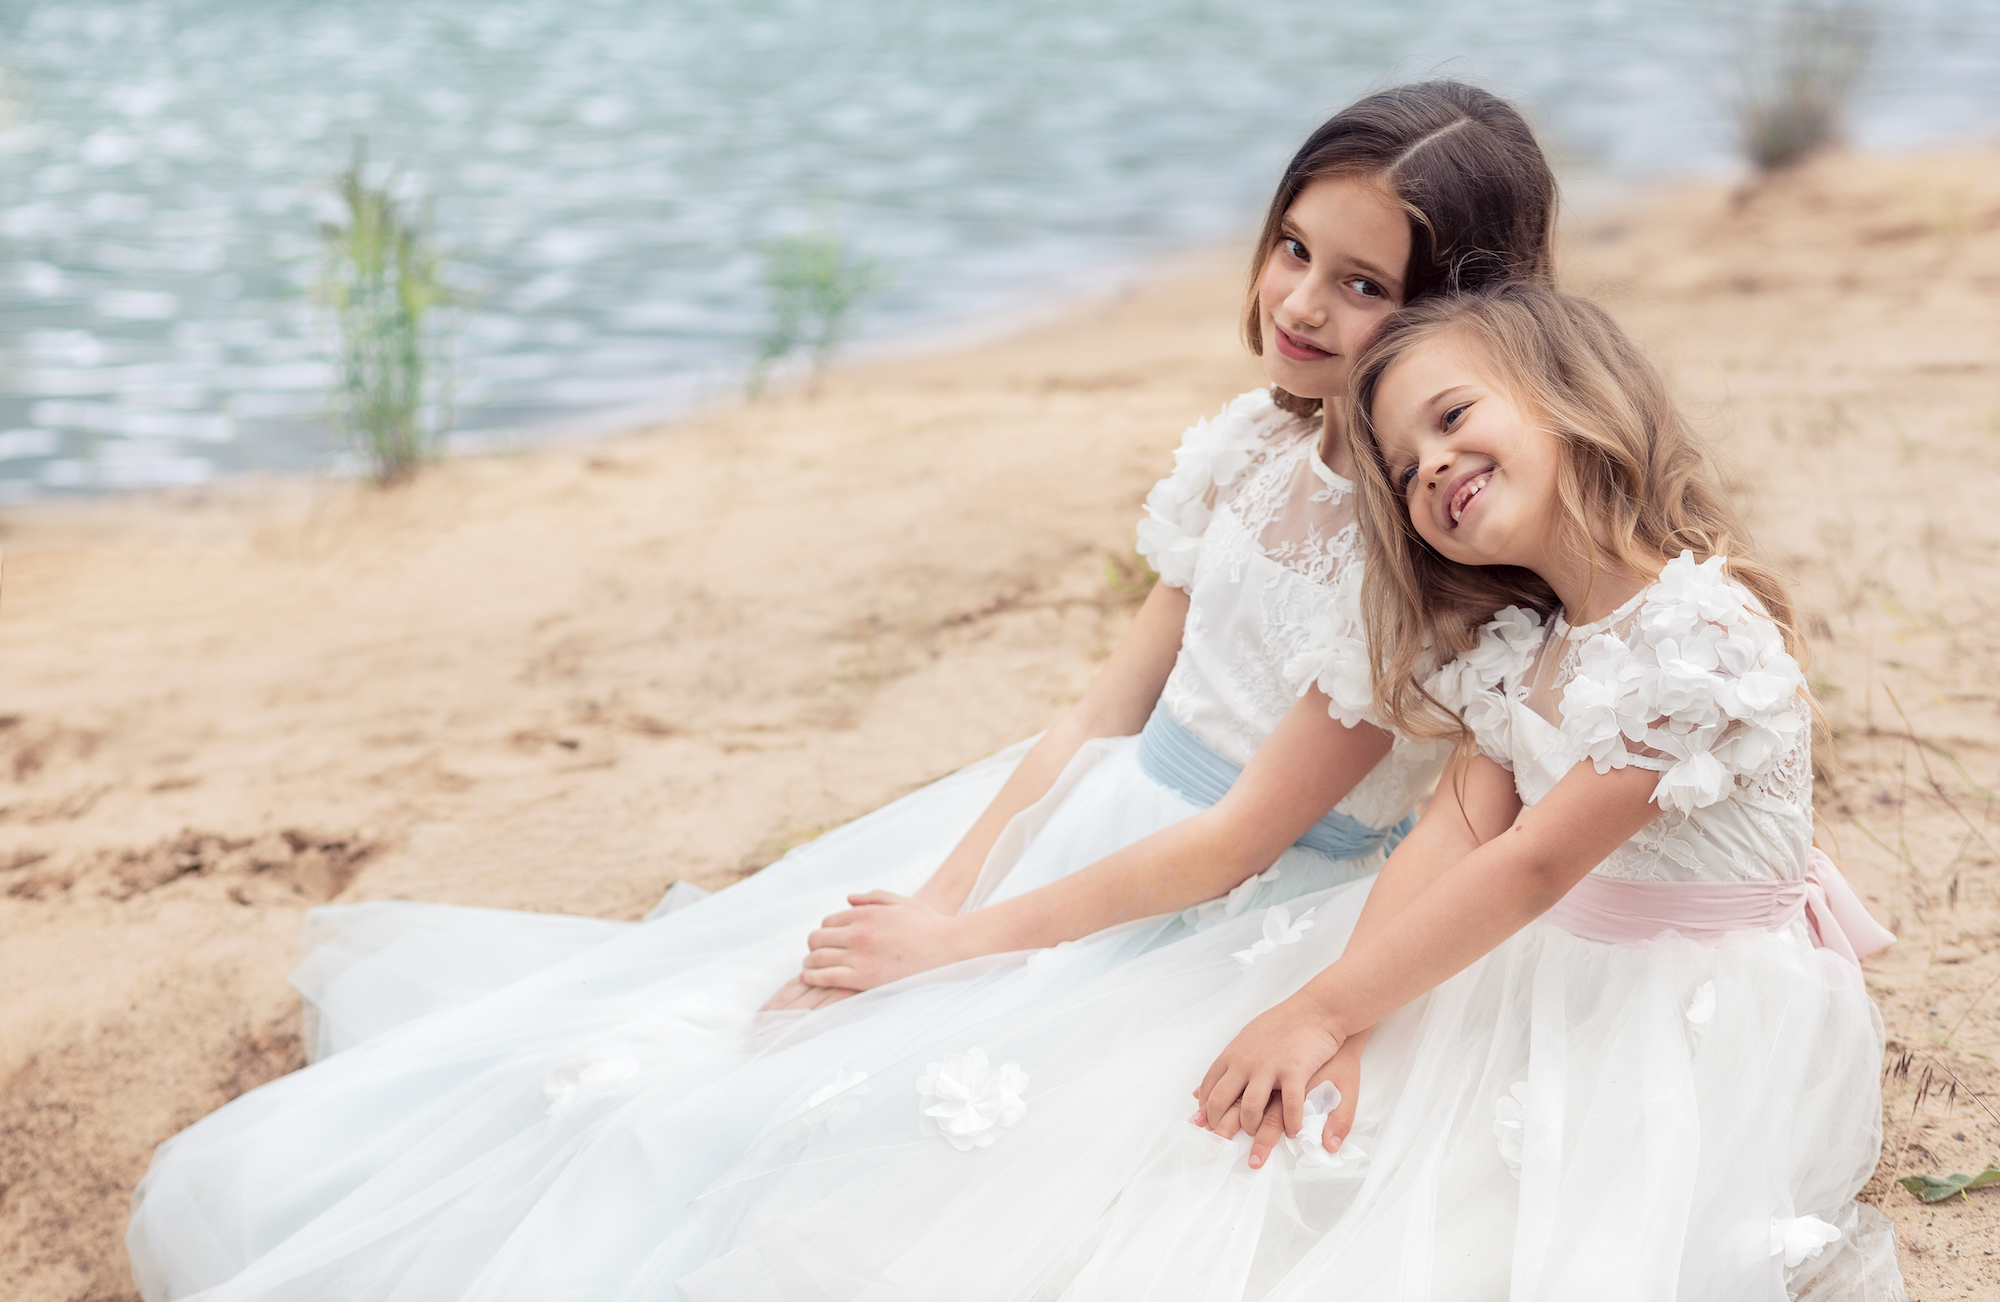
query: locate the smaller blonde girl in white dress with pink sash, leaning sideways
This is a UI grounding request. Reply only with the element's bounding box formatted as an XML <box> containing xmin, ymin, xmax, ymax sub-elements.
<box><xmin>1198</xmin><ymin>284</ymin><xmax>1900</xmax><ymax>1302</ymax></box>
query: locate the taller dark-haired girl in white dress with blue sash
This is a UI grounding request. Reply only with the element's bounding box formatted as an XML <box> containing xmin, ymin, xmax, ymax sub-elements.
<box><xmin>128</xmin><ymin>82</ymin><xmax>1554</xmax><ymax>1302</ymax></box>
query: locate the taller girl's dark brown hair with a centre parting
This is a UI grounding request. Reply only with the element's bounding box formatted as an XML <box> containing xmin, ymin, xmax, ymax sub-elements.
<box><xmin>1244</xmin><ymin>82</ymin><xmax>1556</xmax><ymax>416</ymax></box>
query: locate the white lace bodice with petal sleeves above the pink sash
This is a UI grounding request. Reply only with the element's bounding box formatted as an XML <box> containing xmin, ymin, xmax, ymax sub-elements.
<box><xmin>1432</xmin><ymin>552</ymin><xmax>1812</xmax><ymax>882</ymax></box>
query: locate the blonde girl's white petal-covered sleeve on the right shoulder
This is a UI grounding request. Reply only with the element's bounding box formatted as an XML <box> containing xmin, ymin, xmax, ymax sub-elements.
<box><xmin>1562</xmin><ymin>552</ymin><xmax>1810</xmax><ymax>812</ymax></box>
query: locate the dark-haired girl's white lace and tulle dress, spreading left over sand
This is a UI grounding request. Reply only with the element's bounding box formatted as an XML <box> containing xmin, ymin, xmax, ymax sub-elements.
<box><xmin>128</xmin><ymin>394</ymin><xmax>1442</xmax><ymax>1302</ymax></box>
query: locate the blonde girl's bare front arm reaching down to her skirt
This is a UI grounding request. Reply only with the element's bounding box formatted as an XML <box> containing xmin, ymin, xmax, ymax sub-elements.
<box><xmin>1200</xmin><ymin>756</ymin><xmax>1658</xmax><ymax>1134</ymax></box>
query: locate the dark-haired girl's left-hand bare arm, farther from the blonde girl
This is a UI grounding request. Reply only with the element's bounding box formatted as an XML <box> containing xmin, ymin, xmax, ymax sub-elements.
<box><xmin>916</xmin><ymin>584</ymin><xmax>1188</xmax><ymax>914</ymax></box>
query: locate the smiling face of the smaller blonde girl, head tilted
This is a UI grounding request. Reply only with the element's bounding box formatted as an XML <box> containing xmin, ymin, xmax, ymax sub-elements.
<box><xmin>1374</xmin><ymin>332</ymin><xmax>1562</xmax><ymax>578</ymax></box>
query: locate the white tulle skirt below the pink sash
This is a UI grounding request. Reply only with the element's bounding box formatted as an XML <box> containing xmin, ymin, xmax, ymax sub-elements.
<box><xmin>676</xmin><ymin>884</ymin><xmax>1902</xmax><ymax>1302</ymax></box>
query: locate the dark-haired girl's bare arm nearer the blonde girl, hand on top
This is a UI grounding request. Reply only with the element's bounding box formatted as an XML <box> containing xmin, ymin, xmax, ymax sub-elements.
<box><xmin>804</xmin><ymin>688</ymin><xmax>1390</xmax><ymax>988</ymax></box>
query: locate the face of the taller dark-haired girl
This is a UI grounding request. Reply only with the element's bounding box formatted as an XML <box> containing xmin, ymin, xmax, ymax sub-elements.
<box><xmin>1258</xmin><ymin>176</ymin><xmax>1410</xmax><ymax>398</ymax></box>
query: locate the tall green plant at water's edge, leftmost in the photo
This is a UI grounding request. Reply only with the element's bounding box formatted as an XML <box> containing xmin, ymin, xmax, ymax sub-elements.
<box><xmin>318</xmin><ymin>142</ymin><xmax>450</xmax><ymax>484</ymax></box>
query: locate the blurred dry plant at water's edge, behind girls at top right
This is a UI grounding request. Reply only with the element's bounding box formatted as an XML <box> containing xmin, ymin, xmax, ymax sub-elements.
<box><xmin>1728</xmin><ymin>0</ymin><xmax>1876</xmax><ymax>172</ymax></box>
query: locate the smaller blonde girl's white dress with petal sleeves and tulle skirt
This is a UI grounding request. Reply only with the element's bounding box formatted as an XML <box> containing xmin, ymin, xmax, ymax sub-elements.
<box><xmin>628</xmin><ymin>558</ymin><xmax>1904</xmax><ymax>1302</ymax></box>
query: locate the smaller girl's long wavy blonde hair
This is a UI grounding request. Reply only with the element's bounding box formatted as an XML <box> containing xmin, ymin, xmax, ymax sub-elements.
<box><xmin>1346</xmin><ymin>282</ymin><xmax>1818</xmax><ymax>740</ymax></box>
